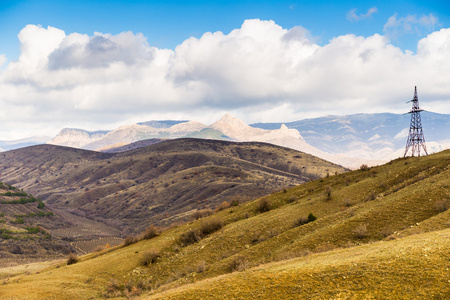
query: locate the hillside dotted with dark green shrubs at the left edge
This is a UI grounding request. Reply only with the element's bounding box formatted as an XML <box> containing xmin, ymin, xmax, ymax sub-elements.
<box><xmin>0</xmin><ymin>182</ymin><xmax>75</xmax><ymax>267</ymax></box>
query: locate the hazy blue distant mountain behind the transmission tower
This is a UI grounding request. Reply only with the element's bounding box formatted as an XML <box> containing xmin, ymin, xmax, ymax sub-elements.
<box><xmin>251</xmin><ymin>111</ymin><xmax>450</xmax><ymax>161</ymax></box>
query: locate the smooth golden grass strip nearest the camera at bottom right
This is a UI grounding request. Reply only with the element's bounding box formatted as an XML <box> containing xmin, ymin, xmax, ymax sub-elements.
<box><xmin>143</xmin><ymin>229</ymin><xmax>450</xmax><ymax>299</ymax></box>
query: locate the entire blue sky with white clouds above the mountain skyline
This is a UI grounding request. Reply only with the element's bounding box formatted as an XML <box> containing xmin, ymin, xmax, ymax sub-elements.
<box><xmin>0</xmin><ymin>0</ymin><xmax>450</xmax><ymax>140</ymax></box>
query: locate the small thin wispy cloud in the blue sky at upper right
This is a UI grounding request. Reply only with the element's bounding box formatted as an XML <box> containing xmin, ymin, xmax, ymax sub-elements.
<box><xmin>383</xmin><ymin>13</ymin><xmax>438</xmax><ymax>40</ymax></box>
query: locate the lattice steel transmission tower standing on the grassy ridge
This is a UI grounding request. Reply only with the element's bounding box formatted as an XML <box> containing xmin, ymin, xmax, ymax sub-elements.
<box><xmin>403</xmin><ymin>86</ymin><xmax>428</xmax><ymax>157</ymax></box>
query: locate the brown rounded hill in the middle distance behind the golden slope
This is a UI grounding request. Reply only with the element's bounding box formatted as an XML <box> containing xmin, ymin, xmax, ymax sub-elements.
<box><xmin>0</xmin><ymin>139</ymin><xmax>346</xmax><ymax>235</ymax></box>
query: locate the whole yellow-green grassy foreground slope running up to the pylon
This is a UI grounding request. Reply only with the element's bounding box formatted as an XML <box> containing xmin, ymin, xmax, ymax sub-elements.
<box><xmin>0</xmin><ymin>151</ymin><xmax>450</xmax><ymax>299</ymax></box>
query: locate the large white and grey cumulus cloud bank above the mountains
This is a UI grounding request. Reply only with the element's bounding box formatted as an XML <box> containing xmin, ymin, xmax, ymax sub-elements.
<box><xmin>0</xmin><ymin>20</ymin><xmax>450</xmax><ymax>139</ymax></box>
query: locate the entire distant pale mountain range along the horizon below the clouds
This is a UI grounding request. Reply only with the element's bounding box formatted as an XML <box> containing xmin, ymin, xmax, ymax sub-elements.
<box><xmin>0</xmin><ymin>111</ymin><xmax>450</xmax><ymax>169</ymax></box>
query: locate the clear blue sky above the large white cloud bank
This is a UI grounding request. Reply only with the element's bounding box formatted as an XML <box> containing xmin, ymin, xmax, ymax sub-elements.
<box><xmin>0</xmin><ymin>0</ymin><xmax>450</xmax><ymax>60</ymax></box>
